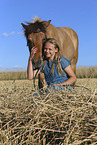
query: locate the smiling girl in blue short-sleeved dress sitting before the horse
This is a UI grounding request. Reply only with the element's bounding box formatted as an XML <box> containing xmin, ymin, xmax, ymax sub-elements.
<box><xmin>28</xmin><ymin>38</ymin><xmax>76</xmax><ymax>89</ymax></box>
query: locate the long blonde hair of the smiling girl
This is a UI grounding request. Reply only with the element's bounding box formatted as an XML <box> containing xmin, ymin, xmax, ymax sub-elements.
<box><xmin>42</xmin><ymin>38</ymin><xmax>65</xmax><ymax>75</ymax></box>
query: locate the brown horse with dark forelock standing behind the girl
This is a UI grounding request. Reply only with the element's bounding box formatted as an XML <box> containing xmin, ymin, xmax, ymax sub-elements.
<box><xmin>21</xmin><ymin>18</ymin><xmax>78</xmax><ymax>88</ymax></box>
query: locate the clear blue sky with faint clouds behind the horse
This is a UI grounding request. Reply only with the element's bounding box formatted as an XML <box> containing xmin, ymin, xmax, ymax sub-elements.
<box><xmin>0</xmin><ymin>0</ymin><xmax>97</xmax><ymax>70</ymax></box>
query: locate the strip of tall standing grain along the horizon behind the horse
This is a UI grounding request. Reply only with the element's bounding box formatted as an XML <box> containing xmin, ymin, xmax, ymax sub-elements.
<box><xmin>0</xmin><ymin>66</ymin><xmax>97</xmax><ymax>80</ymax></box>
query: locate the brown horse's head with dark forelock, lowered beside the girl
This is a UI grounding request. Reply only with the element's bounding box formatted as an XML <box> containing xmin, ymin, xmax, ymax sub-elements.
<box><xmin>21</xmin><ymin>20</ymin><xmax>51</xmax><ymax>69</ymax></box>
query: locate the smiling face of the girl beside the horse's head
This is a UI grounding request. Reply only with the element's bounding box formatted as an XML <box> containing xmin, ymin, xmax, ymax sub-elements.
<box><xmin>44</xmin><ymin>42</ymin><xmax>58</xmax><ymax>61</ymax></box>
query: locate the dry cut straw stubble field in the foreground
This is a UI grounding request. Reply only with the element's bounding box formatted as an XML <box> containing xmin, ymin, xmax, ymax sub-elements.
<box><xmin>0</xmin><ymin>78</ymin><xmax>97</xmax><ymax>145</ymax></box>
